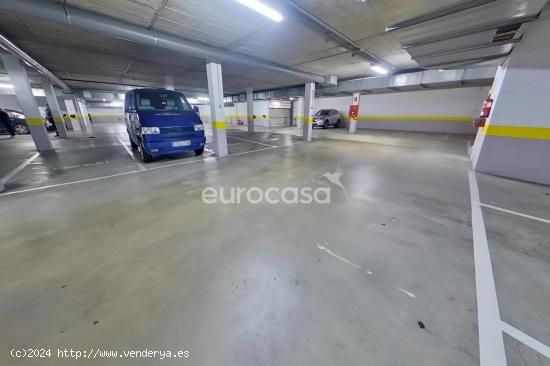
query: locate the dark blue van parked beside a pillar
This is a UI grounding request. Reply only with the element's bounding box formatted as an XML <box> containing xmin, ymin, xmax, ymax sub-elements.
<box><xmin>124</xmin><ymin>89</ymin><xmax>206</xmax><ymax>162</ymax></box>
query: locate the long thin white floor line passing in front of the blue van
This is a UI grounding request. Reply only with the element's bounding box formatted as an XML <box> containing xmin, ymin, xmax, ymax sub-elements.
<box><xmin>0</xmin><ymin>141</ymin><xmax>306</xmax><ymax>197</ymax></box>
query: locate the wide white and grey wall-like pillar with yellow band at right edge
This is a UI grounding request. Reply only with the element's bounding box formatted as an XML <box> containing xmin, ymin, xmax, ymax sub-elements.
<box><xmin>471</xmin><ymin>15</ymin><xmax>550</xmax><ymax>184</ymax></box>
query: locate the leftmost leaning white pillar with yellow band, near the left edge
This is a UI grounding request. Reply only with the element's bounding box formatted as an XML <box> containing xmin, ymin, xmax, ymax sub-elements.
<box><xmin>0</xmin><ymin>53</ymin><xmax>53</xmax><ymax>151</ymax></box>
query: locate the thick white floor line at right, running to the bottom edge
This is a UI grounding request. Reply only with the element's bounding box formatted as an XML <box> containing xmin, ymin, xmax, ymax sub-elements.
<box><xmin>469</xmin><ymin>171</ymin><xmax>506</xmax><ymax>366</ymax></box>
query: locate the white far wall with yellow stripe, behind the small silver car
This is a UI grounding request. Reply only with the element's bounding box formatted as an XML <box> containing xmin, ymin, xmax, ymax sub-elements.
<box><xmin>315</xmin><ymin>87</ymin><xmax>489</xmax><ymax>134</ymax></box>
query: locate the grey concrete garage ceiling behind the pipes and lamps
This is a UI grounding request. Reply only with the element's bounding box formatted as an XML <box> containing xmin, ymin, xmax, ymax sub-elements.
<box><xmin>0</xmin><ymin>0</ymin><xmax>547</xmax><ymax>94</ymax></box>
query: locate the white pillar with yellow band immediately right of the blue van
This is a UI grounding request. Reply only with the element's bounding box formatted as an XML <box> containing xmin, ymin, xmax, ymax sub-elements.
<box><xmin>206</xmin><ymin>62</ymin><xmax>228</xmax><ymax>156</ymax></box>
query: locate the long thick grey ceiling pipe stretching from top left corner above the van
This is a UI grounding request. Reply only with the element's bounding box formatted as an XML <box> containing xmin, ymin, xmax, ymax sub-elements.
<box><xmin>0</xmin><ymin>0</ymin><xmax>324</xmax><ymax>83</ymax></box>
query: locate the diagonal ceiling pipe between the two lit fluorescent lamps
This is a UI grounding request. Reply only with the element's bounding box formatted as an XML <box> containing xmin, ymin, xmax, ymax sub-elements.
<box><xmin>283</xmin><ymin>0</ymin><xmax>393</xmax><ymax>70</ymax></box>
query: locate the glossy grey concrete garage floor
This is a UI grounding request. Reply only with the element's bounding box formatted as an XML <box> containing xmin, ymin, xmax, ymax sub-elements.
<box><xmin>0</xmin><ymin>124</ymin><xmax>550</xmax><ymax>366</ymax></box>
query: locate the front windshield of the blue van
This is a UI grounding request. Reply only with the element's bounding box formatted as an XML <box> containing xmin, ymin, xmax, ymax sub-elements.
<box><xmin>136</xmin><ymin>90</ymin><xmax>193</xmax><ymax>113</ymax></box>
